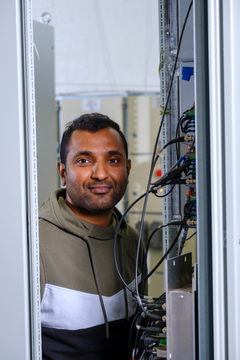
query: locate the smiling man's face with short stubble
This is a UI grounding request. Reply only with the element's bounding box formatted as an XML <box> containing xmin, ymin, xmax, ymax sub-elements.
<box><xmin>59</xmin><ymin>128</ymin><xmax>131</xmax><ymax>215</ymax></box>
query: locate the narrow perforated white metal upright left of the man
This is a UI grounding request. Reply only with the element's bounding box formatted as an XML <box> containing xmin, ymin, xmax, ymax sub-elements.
<box><xmin>22</xmin><ymin>1</ymin><xmax>42</xmax><ymax>360</ymax></box>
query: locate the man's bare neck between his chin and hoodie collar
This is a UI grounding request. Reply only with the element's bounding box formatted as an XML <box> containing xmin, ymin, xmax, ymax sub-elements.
<box><xmin>65</xmin><ymin>199</ymin><xmax>113</xmax><ymax>227</ymax></box>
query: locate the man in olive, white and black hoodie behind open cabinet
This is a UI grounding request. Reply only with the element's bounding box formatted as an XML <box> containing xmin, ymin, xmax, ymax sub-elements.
<box><xmin>39</xmin><ymin>113</ymin><xmax>144</xmax><ymax>360</ymax></box>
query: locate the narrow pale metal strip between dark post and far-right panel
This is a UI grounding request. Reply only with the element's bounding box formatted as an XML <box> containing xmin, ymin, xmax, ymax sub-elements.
<box><xmin>208</xmin><ymin>0</ymin><xmax>227</xmax><ymax>360</ymax></box>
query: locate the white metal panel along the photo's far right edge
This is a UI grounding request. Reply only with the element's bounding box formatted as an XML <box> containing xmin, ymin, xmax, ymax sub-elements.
<box><xmin>222</xmin><ymin>0</ymin><xmax>240</xmax><ymax>359</ymax></box>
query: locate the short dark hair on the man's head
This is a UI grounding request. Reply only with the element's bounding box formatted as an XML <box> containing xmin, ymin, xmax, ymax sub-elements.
<box><xmin>60</xmin><ymin>113</ymin><xmax>128</xmax><ymax>166</ymax></box>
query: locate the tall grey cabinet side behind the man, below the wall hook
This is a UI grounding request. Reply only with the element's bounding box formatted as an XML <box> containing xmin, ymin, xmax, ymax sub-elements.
<box><xmin>33</xmin><ymin>21</ymin><xmax>58</xmax><ymax>206</ymax></box>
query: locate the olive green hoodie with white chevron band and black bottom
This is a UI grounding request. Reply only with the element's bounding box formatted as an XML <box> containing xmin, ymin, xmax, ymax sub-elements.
<box><xmin>39</xmin><ymin>189</ymin><xmax>144</xmax><ymax>360</ymax></box>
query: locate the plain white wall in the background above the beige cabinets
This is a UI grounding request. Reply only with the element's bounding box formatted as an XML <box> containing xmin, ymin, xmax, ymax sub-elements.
<box><xmin>33</xmin><ymin>0</ymin><xmax>159</xmax><ymax>95</ymax></box>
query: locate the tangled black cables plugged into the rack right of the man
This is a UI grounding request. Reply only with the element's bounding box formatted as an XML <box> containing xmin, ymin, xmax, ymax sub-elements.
<box><xmin>114</xmin><ymin>1</ymin><xmax>196</xmax><ymax>360</ymax></box>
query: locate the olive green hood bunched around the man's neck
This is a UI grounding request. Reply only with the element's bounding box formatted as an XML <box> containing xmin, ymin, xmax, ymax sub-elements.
<box><xmin>39</xmin><ymin>188</ymin><xmax>127</xmax><ymax>240</ymax></box>
